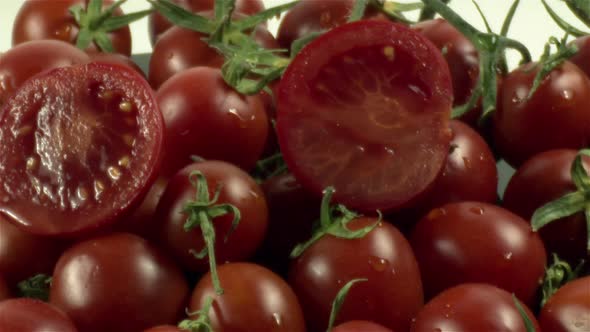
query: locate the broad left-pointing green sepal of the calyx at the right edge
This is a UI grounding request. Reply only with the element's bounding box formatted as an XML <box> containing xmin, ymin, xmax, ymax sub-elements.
<box><xmin>531</xmin><ymin>191</ymin><xmax>588</xmax><ymax>232</ymax></box>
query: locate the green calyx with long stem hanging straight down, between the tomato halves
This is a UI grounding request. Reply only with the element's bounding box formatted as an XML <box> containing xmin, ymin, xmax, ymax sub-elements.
<box><xmin>183</xmin><ymin>171</ymin><xmax>241</xmax><ymax>295</ymax></box>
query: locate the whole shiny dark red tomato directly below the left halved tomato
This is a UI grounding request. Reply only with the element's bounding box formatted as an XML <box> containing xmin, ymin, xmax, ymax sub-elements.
<box><xmin>49</xmin><ymin>233</ymin><xmax>189</xmax><ymax>332</ymax></box>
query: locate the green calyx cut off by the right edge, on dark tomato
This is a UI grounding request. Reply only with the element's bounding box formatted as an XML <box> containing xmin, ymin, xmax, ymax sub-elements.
<box><xmin>531</xmin><ymin>149</ymin><xmax>590</xmax><ymax>252</ymax></box>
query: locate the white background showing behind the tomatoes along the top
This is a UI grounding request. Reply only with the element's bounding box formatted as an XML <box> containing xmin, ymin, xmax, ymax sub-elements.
<box><xmin>0</xmin><ymin>0</ymin><xmax>590</xmax><ymax>65</ymax></box>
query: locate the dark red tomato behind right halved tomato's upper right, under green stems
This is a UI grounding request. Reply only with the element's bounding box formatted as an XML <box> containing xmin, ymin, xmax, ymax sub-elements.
<box><xmin>412</xmin><ymin>18</ymin><xmax>481</xmax><ymax>125</ymax></box>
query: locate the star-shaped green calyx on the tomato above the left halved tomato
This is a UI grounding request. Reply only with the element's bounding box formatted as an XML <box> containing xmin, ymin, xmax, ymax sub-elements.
<box><xmin>69</xmin><ymin>0</ymin><xmax>153</xmax><ymax>53</ymax></box>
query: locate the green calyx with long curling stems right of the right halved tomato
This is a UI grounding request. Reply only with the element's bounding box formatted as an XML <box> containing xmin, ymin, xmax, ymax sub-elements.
<box><xmin>422</xmin><ymin>0</ymin><xmax>531</xmax><ymax>124</ymax></box>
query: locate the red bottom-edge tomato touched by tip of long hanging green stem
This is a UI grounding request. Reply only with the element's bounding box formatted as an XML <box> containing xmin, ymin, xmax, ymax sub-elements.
<box><xmin>188</xmin><ymin>263</ymin><xmax>305</xmax><ymax>332</ymax></box>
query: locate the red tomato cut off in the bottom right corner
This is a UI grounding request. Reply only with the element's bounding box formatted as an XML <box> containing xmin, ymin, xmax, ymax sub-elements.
<box><xmin>539</xmin><ymin>276</ymin><xmax>590</xmax><ymax>332</ymax></box>
